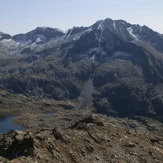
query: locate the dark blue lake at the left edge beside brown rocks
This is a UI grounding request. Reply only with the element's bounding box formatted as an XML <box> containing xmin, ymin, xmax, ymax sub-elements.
<box><xmin>0</xmin><ymin>115</ymin><xmax>25</xmax><ymax>133</ymax></box>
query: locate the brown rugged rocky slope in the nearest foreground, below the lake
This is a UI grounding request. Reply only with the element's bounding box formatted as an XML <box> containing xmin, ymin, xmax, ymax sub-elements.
<box><xmin>0</xmin><ymin>114</ymin><xmax>163</xmax><ymax>163</ymax></box>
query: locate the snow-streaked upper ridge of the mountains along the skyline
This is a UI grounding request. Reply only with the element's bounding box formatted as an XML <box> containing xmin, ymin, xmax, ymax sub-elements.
<box><xmin>0</xmin><ymin>18</ymin><xmax>163</xmax><ymax>54</ymax></box>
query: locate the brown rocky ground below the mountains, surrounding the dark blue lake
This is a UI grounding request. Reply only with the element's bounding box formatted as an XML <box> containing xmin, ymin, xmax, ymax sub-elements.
<box><xmin>0</xmin><ymin>97</ymin><xmax>163</xmax><ymax>163</ymax></box>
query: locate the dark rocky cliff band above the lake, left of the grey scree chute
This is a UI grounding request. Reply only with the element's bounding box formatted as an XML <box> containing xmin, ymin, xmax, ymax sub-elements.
<box><xmin>3</xmin><ymin>77</ymin><xmax>80</xmax><ymax>100</ymax></box>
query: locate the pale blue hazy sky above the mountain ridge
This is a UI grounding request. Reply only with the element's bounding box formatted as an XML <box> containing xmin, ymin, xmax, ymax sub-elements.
<box><xmin>0</xmin><ymin>0</ymin><xmax>163</xmax><ymax>35</ymax></box>
